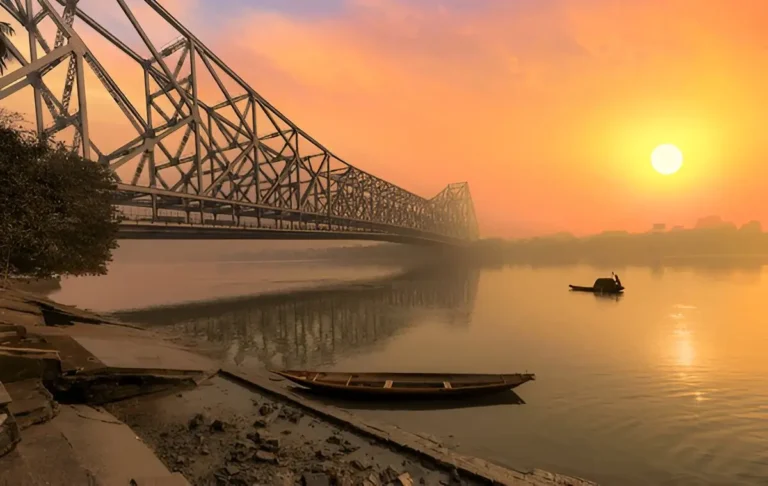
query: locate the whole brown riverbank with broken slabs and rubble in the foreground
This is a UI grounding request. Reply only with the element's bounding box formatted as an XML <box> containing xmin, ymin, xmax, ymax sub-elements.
<box><xmin>0</xmin><ymin>290</ymin><xmax>593</xmax><ymax>486</ymax></box>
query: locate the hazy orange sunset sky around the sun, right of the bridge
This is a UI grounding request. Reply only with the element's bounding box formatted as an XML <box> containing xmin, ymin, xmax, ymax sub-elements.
<box><xmin>6</xmin><ymin>0</ymin><xmax>768</xmax><ymax>236</ymax></box>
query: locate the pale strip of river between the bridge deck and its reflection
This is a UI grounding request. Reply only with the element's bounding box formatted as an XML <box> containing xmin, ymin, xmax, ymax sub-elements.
<box><xmin>51</xmin><ymin>240</ymin><xmax>402</xmax><ymax>311</ymax></box>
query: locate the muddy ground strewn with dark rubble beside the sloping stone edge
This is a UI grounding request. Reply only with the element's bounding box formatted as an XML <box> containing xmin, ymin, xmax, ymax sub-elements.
<box><xmin>107</xmin><ymin>376</ymin><xmax>477</xmax><ymax>486</ymax></box>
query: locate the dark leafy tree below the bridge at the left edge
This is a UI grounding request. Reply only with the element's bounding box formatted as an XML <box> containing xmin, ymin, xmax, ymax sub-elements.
<box><xmin>0</xmin><ymin>109</ymin><xmax>119</xmax><ymax>278</ymax></box>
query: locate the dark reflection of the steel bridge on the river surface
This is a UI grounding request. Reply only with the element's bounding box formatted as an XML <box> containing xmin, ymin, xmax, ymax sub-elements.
<box><xmin>117</xmin><ymin>267</ymin><xmax>479</xmax><ymax>368</ymax></box>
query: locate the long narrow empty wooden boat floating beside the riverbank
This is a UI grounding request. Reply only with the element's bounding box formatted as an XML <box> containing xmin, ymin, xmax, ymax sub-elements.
<box><xmin>272</xmin><ymin>370</ymin><xmax>536</xmax><ymax>399</ymax></box>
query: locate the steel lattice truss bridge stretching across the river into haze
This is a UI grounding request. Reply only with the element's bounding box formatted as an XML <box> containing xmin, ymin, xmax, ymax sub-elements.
<box><xmin>0</xmin><ymin>0</ymin><xmax>478</xmax><ymax>241</ymax></box>
